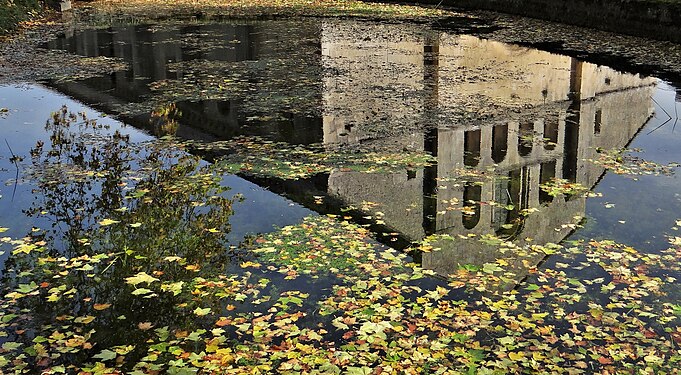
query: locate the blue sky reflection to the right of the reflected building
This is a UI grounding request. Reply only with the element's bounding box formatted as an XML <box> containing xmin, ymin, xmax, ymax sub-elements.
<box><xmin>577</xmin><ymin>83</ymin><xmax>681</xmax><ymax>252</ymax></box>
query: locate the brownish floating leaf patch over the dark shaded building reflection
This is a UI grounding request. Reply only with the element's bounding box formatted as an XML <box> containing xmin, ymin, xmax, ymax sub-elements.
<box><xmin>118</xmin><ymin>38</ymin><xmax>321</xmax><ymax>118</ymax></box>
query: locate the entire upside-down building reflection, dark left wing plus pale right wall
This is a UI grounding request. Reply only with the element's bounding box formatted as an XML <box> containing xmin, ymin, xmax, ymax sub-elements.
<box><xmin>48</xmin><ymin>20</ymin><xmax>655</xmax><ymax>272</ymax></box>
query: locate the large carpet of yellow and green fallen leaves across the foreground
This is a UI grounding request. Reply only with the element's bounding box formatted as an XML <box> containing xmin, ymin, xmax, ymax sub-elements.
<box><xmin>0</xmin><ymin>210</ymin><xmax>681</xmax><ymax>374</ymax></box>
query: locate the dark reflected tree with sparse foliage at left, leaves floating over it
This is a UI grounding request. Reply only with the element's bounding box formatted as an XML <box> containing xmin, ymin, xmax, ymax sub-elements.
<box><xmin>0</xmin><ymin>107</ymin><xmax>239</xmax><ymax>370</ymax></box>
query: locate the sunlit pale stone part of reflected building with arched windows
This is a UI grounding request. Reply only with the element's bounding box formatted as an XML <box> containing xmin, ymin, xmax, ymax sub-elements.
<box><xmin>322</xmin><ymin>24</ymin><xmax>655</xmax><ymax>273</ymax></box>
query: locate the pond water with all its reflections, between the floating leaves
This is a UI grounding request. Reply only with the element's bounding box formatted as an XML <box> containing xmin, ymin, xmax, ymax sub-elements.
<box><xmin>0</xmin><ymin>19</ymin><xmax>681</xmax><ymax>373</ymax></box>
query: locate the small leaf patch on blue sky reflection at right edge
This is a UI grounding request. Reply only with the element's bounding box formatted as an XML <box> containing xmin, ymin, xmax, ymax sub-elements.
<box><xmin>587</xmin><ymin>149</ymin><xmax>679</xmax><ymax>176</ymax></box>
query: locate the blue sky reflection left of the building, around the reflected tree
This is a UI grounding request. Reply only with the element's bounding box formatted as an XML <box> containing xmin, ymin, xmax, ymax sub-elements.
<box><xmin>0</xmin><ymin>85</ymin><xmax>311</xmax><ymax>272</ymax></box>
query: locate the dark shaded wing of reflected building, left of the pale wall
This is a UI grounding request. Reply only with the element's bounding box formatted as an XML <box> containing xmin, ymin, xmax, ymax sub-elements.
<box><xmin>46</xmin><ymin>21</ymin><xmax>322</xmax><ymax>143</ymax></box>
